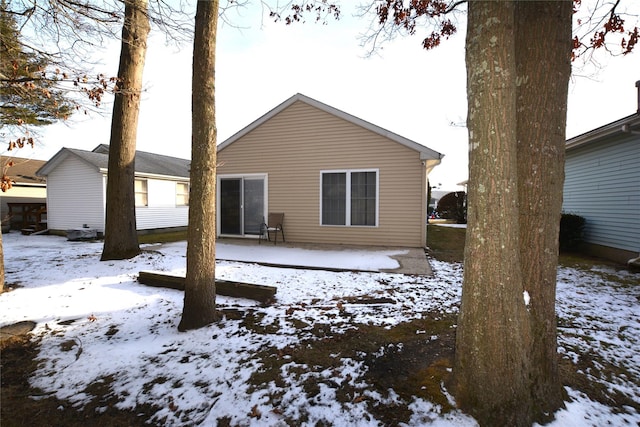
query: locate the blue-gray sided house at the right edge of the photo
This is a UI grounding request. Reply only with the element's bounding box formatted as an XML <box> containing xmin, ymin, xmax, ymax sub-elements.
<box><xmin>562</xmin><ymin>93</ymin><xmax>640</xmax><ymax>263</ymax></box>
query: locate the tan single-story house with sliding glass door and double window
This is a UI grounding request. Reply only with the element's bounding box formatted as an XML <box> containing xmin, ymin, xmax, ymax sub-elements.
<box><xmin>217</xmin><ymin>94</ymin><xmax>443</xmax><ymax>247</ymax></box>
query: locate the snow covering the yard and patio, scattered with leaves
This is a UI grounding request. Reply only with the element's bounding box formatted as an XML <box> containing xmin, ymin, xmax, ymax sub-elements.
<box><xmin>0</xmin><ymin>233</ymin><xmax>640</xmax><ymax>426</ymax></box>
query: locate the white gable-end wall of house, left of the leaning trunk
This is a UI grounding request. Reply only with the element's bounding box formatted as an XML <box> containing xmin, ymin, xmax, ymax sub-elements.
<box><xmin>47</xmin><ymin>155</ymin><xmax>104</xmax><ymax>232</ymax></box>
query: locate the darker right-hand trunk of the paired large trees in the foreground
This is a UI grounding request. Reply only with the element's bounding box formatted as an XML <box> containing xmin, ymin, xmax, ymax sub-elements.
<box><xmin>516</xmin><ymin>1</ymin><xmax>572</xmax><ymax>422</ymax></box>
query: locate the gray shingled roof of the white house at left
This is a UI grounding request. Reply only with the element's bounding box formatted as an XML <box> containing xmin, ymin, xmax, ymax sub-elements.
<box><xmin>36</xmin><ymin>144</ymin><xmax>191</xmax><ymax>179</ymax></box>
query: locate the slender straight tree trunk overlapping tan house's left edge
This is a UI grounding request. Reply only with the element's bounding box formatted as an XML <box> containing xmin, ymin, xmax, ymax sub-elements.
<box><xmin>178</xmin><ymin>0</ymin><xmax>218</xmax><ymax>331</ymax></box>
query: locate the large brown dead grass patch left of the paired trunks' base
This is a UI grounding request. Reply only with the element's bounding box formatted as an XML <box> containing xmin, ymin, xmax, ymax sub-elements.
<box><xmin>245</xmin><ymin>315</ymin><xmax>455</xmax><ymax>425</ymax></box>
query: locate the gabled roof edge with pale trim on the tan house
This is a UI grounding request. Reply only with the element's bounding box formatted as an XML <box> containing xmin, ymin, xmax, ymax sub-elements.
<box><xmin>218</xmin><ymin>93</ymin><xmax>444</xmax><ymax>164</ymax></box>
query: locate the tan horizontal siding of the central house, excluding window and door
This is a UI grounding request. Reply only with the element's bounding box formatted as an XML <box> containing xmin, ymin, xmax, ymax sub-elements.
<box><xmin>218</xmin><ymin>102</ymin><xmax>426</xmax><ymax>247</ymax></box>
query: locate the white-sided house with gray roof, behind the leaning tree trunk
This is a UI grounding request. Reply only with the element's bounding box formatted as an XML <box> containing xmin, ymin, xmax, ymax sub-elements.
<box><xmin>37</xmin><ymin>145</ymin><xmax>190</xmax><ymax>233</ymax></box>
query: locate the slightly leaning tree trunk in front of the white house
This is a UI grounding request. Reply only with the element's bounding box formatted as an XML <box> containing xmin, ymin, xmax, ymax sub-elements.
<box><xmin>101</xmin><ymin>0</ymin><xmax>150</xmax><ymax>261</ymax></box>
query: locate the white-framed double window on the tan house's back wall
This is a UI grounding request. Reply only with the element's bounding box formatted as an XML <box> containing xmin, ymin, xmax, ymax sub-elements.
<box><xmin>320</xmin><ymin>170</ymin><xmax>378</xmax><ymax>226</ymax></box>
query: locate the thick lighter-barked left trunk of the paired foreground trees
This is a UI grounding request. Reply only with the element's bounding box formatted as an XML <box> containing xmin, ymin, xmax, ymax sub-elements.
<box><xmin>454</xmin><ymin>1</ymin><xmax>531</xmax><ymax>426</ymax></box>
